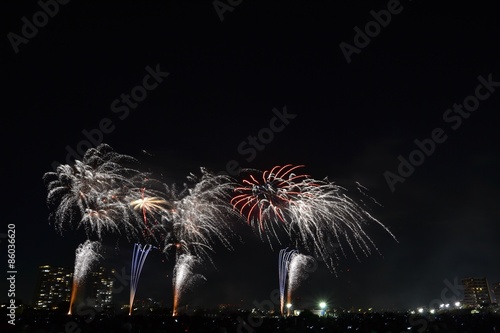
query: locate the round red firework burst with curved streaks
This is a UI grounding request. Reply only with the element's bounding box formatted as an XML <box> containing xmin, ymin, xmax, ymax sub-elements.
<box><xmin>231</xmin><ymin>164</ymin><xmax>308</xmax><ymax>229</ymax></box>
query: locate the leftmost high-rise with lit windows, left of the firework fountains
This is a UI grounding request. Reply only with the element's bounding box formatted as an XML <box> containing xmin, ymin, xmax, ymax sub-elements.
<box><xmin>35</xmin><ymin>265</ymin><xmax>73</xmax><ymax>310</ymax></box>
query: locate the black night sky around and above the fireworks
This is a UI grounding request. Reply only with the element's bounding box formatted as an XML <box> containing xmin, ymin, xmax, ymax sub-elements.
<box><xmin>1</xmin><ymin>0</ymin><xmax>500</xmax><ymax>308</ymax></box>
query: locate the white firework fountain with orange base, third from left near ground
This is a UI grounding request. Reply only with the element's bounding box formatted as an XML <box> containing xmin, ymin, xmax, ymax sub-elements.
<box><xmin>172</xmin><ymin>254</ymin><xmax>205</xmax><ymax>316</ymax></box>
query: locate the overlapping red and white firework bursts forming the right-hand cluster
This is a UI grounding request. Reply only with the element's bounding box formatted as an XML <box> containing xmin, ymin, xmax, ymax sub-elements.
<box><xmin>231</xmin><ymin>164</ymin><xmax>395</xmax><ymax>272</ymax></box>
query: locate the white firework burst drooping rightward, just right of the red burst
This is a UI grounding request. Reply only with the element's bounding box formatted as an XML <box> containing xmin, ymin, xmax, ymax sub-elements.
<box><xmin>288</xmin><ymin>179</ymin><xmax>396</xmax><ymax>270</ymax></box>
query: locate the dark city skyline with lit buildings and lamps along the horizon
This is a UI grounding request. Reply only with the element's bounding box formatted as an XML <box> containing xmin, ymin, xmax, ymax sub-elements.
<box><xmin>13</xmin><ymin>265</ymin><xmax>500</xmax><ymax>311</ymax></box>
